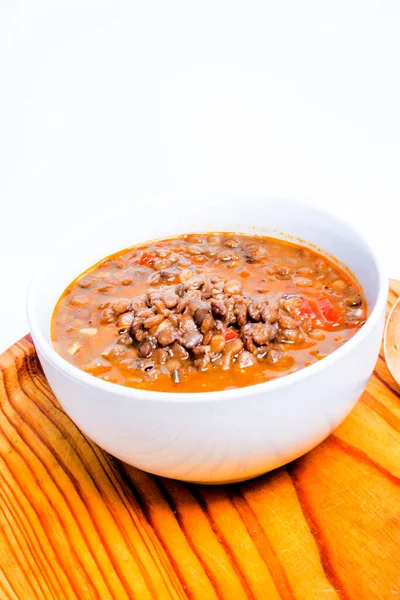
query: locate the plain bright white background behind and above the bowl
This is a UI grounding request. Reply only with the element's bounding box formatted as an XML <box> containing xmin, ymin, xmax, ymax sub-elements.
<box><xmin>0</xmin><ymin>0</ymin><xmax>400</xmax><ymax>351</ymax></box>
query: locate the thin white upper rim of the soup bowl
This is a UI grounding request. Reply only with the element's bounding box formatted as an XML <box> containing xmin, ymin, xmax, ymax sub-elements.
<box><xmin>26</xmin><ymin>194</ymin><xmax>389</xmax><ymax>403</ymax></box>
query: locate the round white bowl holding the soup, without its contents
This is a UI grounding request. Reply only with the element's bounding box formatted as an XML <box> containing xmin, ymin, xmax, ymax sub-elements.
<box><xmin>28</xmin><ymin>197</ymin><xmax>388</xmax><ymax>483</ymax></box>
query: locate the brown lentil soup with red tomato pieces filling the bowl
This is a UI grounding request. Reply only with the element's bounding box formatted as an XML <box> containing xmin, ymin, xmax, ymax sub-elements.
<box><xmin>51</xmin><ymin>233</ymin><xmax>367</xmax><ymax>392</ymax></box>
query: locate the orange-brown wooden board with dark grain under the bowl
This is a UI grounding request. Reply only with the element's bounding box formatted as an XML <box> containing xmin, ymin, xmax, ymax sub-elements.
<box><xmin>0</xmin><ymin>282</ymin><xmax>400</xmax><ymax>600</ymax></box>
